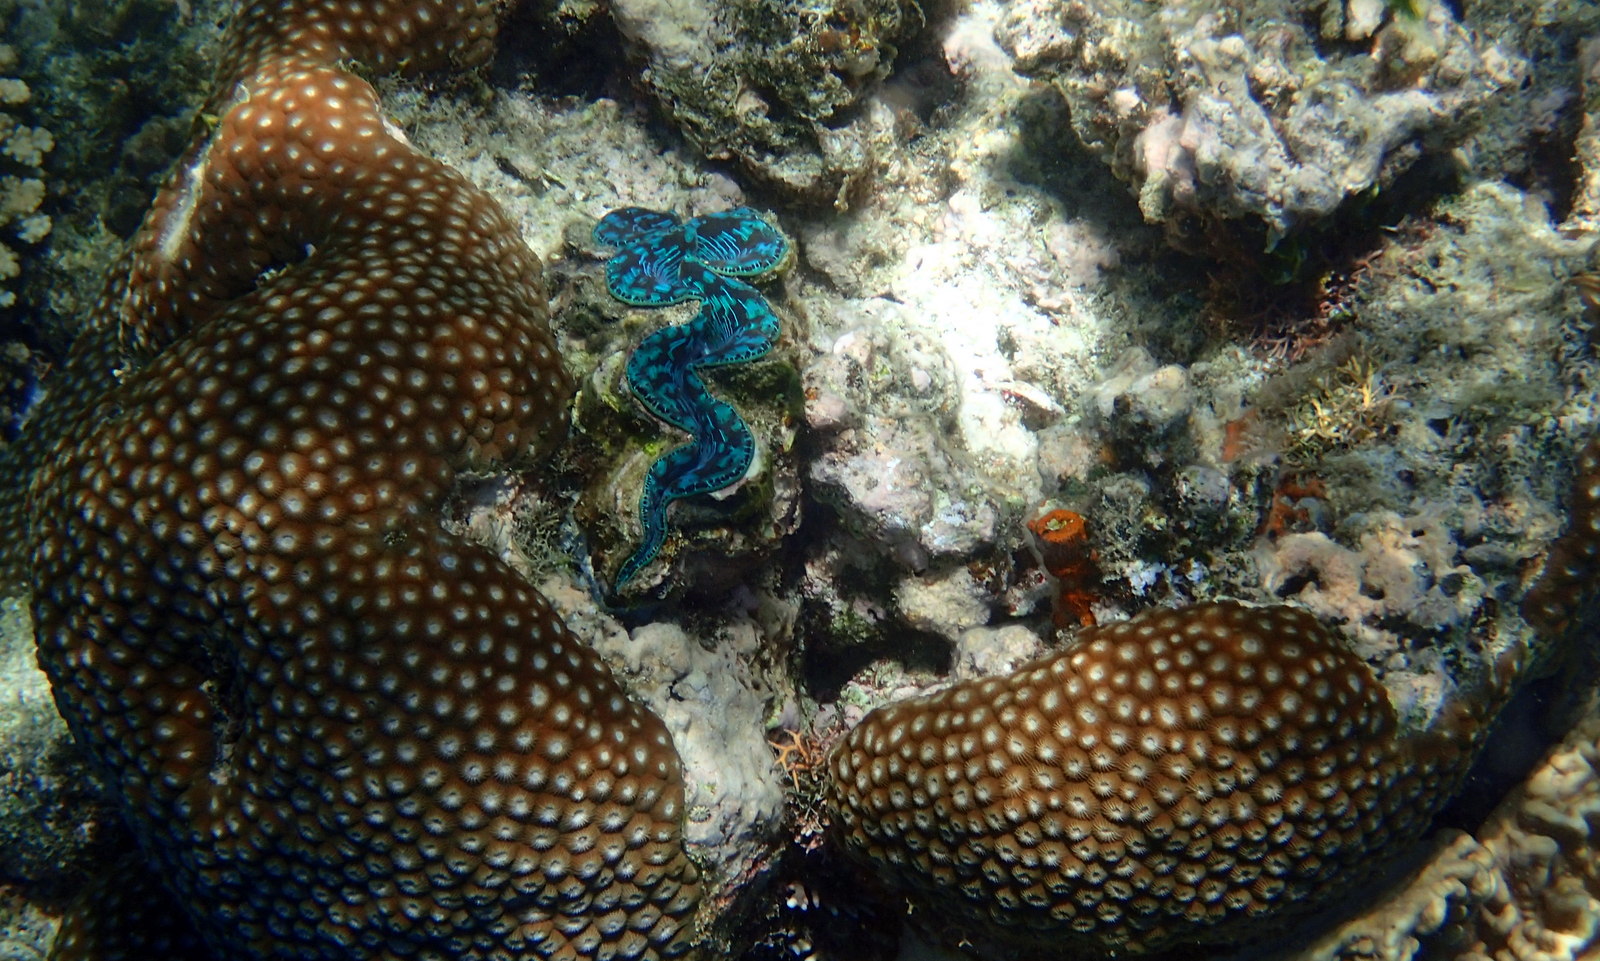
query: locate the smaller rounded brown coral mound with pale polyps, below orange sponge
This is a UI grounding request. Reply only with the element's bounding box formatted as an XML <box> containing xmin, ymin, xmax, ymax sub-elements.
<box><xmin>829</xmin><ymin>603</ymin><xmax>1482</xmax><ymax>956</ymax></box>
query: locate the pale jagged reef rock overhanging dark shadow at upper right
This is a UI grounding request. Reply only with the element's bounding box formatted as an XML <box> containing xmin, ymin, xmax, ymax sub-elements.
<box><xmin>998</xmin><ymin>0</ymin><xmax>1523</xmax><ymax>240</ymax></box>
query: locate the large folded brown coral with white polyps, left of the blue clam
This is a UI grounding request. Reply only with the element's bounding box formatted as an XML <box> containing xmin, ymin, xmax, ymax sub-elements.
<box><xmin>15</xmin><ymin>0</ymin><xmax>698</xmax><ymax>959</ymax></box>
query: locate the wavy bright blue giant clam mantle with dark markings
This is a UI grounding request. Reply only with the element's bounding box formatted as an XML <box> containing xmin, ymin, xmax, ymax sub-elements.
<box><xmin>594</xmin><ymin>206</ymin><xmax>789</xmax><ymax>590</ymax></box>
